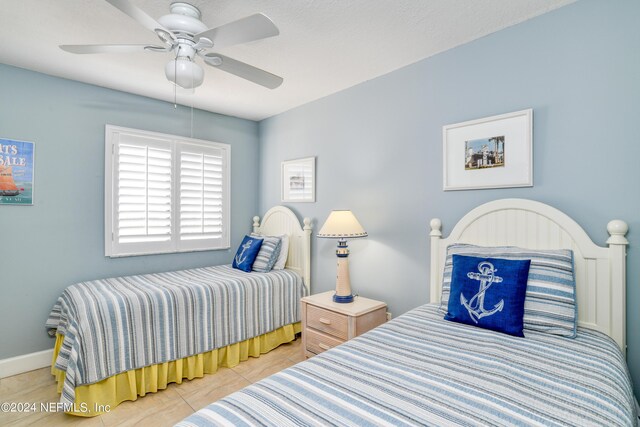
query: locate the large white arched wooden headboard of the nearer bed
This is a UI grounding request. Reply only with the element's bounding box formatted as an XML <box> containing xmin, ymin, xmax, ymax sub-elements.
<box><xmin>430</xmin><ymin>199</ymin><xmax>629</xmax><ymax>353</ymax></box>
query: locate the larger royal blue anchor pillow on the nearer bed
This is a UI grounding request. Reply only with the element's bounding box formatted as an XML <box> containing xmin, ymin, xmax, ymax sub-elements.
<box><xmin>444</xmin><ymin>255</ymin><xmax>531</xmax><ymax>337</ymax></box>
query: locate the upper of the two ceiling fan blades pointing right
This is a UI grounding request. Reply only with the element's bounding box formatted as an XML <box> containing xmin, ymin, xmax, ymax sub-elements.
<box><xmin>194</xmin><ymin>13</ymin><xmax>280</xmax><ymax>49</ymax></box>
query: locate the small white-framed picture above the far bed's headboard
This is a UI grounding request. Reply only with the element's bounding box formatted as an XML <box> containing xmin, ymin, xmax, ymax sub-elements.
<box><xmin>280</xmin><ymin>157</ymin><xmax>316</xmax><ymax>203</ymax></box>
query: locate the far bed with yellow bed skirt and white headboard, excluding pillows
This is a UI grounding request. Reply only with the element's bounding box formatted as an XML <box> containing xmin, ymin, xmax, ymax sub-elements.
<box><xmin>46</xmin><ymin>206</ymin><xmax>311</xmax><ymax>416</ymax></box>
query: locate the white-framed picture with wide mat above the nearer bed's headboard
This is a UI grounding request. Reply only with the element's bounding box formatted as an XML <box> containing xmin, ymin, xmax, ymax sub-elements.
<box><xmin>442</xmin><ymin>109</ymin><xmax>533</xmax><ymax>191</ymax></box>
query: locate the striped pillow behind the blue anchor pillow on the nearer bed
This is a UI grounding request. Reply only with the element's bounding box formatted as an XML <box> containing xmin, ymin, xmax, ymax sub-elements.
<box><xmin>440</xmin><ymin>243</ymin><xmax>577</xmax><ymax>338</ymax></box>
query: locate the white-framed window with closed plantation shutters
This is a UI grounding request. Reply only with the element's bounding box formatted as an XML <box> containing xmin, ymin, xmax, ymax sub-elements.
<box><xmin>105</xmin><ymin>125</ymin><xmax>230</xmax><ymax>257</ymax></box>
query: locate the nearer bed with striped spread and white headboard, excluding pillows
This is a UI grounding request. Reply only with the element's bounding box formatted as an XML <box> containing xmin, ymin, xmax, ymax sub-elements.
<box><xmin>178</xmin><ymin>199</ymin><xmax>637</xmax><ymax>427</ymax></box>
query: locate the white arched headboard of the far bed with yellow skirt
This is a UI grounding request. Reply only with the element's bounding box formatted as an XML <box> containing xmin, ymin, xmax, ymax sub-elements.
<box><xmin>253</xmin><ymin>206</ymin><xmax>311</xmax><ymax>294</ymax></box>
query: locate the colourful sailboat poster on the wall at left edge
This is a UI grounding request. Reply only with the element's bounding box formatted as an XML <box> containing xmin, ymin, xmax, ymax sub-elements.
<box><xmin>0</xmin><ymin>138</ymin><xmax>35</xmax><ymax>205</ymax></box>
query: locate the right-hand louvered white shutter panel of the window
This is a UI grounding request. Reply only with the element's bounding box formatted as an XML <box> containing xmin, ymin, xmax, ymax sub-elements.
<box><xmin>178</xmin><ymin>144</ymin><xmax>228</xmax><ymax>249</ymax></box>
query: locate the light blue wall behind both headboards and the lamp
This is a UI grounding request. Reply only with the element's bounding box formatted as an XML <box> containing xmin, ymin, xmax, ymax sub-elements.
<box><xmin>260</xmin><ymin>0</ymin><xmax>640</xmax><ymax>391</ymax></box>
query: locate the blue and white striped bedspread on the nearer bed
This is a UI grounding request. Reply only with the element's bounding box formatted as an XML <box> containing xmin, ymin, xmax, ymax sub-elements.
<box><xmin>178</xmin><ymin>305</ymin><xmax>635</xmax><ymax>427</ymax></box>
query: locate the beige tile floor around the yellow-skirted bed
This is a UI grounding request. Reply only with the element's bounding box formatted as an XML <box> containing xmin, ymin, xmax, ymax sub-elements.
<box><xmin>0</xmin><ymin>338</ymin><xmax>304</xmax><ymax>427</ymax></box>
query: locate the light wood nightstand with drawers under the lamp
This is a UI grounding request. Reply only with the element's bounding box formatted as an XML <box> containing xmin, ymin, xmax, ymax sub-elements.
<box><xmin>300</xmin><ymin>291</ymin><xmax>387</xmax><ymax>357</ymax></box>
